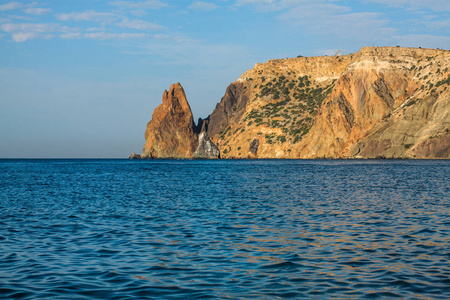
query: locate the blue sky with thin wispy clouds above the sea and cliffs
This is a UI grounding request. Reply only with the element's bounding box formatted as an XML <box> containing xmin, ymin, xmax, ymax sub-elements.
<box><xmin>0</xmin><ymin>0</ymin><xmax>450</xmax><ymax>158</ymax></box>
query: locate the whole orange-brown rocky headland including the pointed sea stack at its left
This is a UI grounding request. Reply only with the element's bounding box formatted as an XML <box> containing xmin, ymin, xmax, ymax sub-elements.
<box><xmin>135</xmin><ymin>47</ymin><xmax>450</xmax><ymax>158</ymax></box>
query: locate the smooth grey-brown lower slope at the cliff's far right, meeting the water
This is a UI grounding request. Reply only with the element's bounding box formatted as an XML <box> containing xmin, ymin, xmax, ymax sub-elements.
<box><xmin>349</xmin><ymin>94</ymin><xmax>450</xmax><ymax>158</ymax></box>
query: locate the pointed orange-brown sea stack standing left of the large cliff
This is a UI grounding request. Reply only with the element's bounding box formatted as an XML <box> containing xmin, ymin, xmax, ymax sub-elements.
<box><xmin>142</xmin><ymin>83</ymin><xmax>198</xmax><ymax>158</ymax></box>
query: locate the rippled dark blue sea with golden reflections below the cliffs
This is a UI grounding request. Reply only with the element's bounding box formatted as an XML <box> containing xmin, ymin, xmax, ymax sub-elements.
<box><xmin>0</xmin><ymin>160</ymin><xmax>450</xmax><ymax>299</ymax></box>
